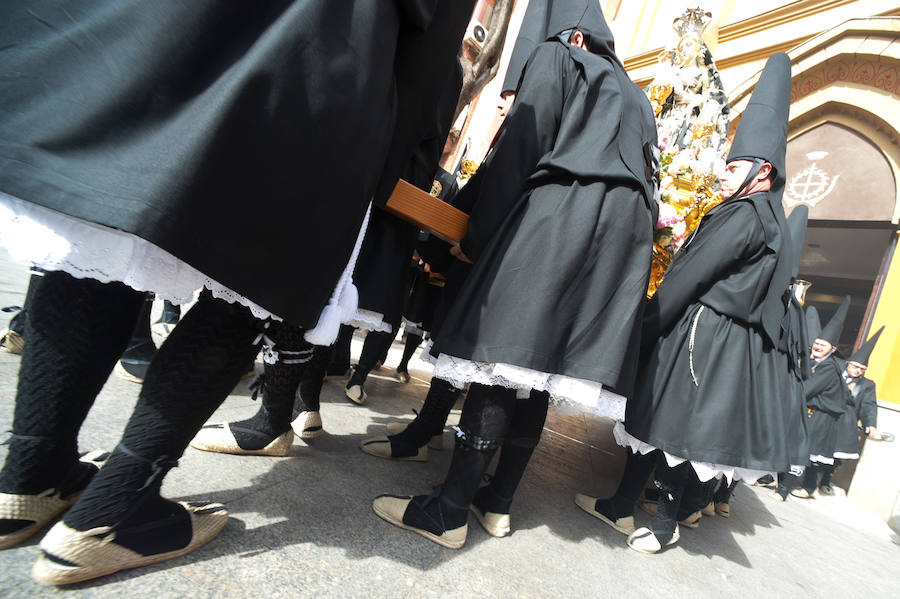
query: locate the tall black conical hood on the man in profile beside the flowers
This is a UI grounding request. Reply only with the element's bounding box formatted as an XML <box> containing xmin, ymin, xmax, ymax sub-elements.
<box><xmin>726</xmin><ymin>53</ymin><xmax>791</xmax><ymax>195</ymax></box>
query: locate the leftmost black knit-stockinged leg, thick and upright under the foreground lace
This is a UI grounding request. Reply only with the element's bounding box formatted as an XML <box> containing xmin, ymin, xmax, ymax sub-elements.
<box><xmin>0</xmin><ymin>272</ymin><xmax>144</xmax><ymax>494</ymax></box>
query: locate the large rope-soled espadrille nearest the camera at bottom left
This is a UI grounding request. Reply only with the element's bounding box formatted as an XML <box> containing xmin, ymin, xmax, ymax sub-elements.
<box><xmin>31</xmin><ymin>501</ymin><xmax>228</xmax><ymax>585</ymax></box>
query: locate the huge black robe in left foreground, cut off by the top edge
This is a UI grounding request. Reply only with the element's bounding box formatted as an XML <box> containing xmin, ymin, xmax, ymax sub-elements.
<box><xmin>0</xmin><ymin>0</ymin><xmax>471</xmax><ymax>326</ymax></box>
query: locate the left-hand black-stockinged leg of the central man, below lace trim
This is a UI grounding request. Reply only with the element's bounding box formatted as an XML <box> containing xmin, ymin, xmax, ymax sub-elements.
<box><xmin>403</xmin><ymin>383</ymin><xmax>518</xmax><ymax>533</ymax></box>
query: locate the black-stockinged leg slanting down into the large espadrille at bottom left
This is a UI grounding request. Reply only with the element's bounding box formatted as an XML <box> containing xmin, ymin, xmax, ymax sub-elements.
<box><xmin>64</xmin><ymin>292</ymin><xmax>261</xmax><ymax>536</ymax></box>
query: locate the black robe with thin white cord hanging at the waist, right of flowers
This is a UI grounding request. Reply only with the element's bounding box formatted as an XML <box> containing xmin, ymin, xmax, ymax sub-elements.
<box><xmin>625</xmin><ymin>193</ymin><xmax>792</xmax><ymax>472</ymax></box>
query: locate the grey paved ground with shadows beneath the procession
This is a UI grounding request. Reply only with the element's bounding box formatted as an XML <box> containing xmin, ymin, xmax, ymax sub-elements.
<box><xmin>0</xmin><ymin>257</ymin><xmax>900</xmax><ymax>598</ymax></box>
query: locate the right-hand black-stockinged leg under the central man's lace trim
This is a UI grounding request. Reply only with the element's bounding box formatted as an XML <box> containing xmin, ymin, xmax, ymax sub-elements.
<box><xmin>475</xmin><ymin>390</ymin><xmax>550</xmax><ymax>514</ymax></box>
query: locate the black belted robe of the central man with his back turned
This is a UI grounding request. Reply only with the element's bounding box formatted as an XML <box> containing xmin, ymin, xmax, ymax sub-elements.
<box><xmin>435</xmin><ymin>41</ymin><xmax>656</xmax><ymax>394</ymax></box>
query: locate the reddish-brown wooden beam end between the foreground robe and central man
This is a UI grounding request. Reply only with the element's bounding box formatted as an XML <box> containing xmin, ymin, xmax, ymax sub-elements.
<box><xmin>383</xmin><ymin>179</ymin><xmax>469</xmax><ymax>243</ymax></box>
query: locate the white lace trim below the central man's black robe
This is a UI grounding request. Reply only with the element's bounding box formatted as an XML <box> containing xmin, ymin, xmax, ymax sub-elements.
<box><xmin>434</xmin><ymin>354</ymin><xmax>625</xmax><ymax>420</ymax></box>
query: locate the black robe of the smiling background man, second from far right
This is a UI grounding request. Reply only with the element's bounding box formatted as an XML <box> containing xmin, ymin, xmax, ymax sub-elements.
<box><xmin>806</xmin><ymin>354</ymin><xmax>856</xmax><ymax>459</ymax></box>
